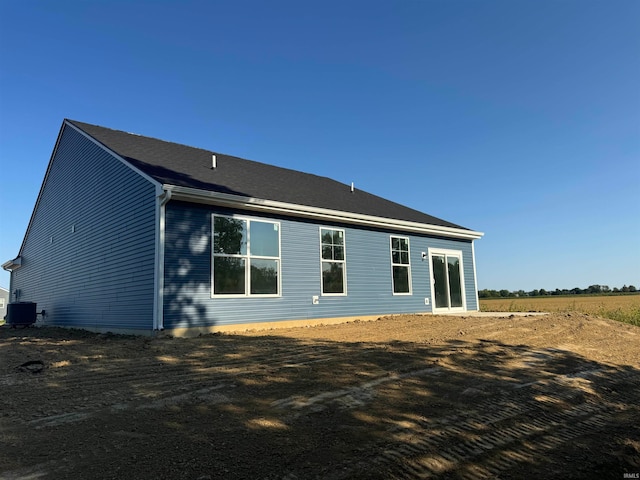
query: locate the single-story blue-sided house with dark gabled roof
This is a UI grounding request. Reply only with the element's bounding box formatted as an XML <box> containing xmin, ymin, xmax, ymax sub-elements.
<box><xmin>3</xmin><ymin>120</ymin><xmax>483</xmax><ymax>334</ymax></box>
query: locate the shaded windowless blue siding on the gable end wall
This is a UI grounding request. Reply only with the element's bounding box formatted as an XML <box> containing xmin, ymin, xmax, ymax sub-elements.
<box><xmin>12</xmin><ymin>126</ymin><xmax>156</xmax><ymax>330</ymax></box>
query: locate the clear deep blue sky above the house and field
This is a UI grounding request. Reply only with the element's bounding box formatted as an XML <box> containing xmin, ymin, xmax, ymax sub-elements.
<box><xmin>0</xmin><ymin>0</ymin><xmax>640</xmax><ymax>290</ymax></box>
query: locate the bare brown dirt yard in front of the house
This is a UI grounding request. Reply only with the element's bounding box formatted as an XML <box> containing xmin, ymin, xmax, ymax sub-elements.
<box><xmin>0</xmin><ymin>313</ymin><xmax>640</xmax><ymax>480</ymax></box>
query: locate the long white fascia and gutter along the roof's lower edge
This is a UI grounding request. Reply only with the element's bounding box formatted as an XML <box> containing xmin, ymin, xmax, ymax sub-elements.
<box><xmin>163</xmin><ymin>185</ymin><xmax>484</xmax><ymax>240</ymax></box>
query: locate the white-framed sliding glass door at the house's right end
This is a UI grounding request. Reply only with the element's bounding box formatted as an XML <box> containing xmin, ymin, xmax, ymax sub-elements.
<box><xmin>429</xmin><ymin>250</ymin><xmax>466</xmax><ymax>312</ymax></box>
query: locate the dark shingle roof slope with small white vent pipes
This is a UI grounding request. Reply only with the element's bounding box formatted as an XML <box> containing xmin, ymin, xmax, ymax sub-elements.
<box><xmin>67</xmin><ymin>120</ymin><xmax>467</xmax><ymax>230</ymax></box>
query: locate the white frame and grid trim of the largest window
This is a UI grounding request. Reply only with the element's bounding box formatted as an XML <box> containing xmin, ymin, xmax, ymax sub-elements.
<box><xmin>211</xmin><ymin>213</ymin><xmax>282</xmax><ymax>298</ymax></box>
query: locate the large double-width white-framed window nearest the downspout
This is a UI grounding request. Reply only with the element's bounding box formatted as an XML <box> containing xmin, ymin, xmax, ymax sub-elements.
<box><xmin>213</xmin><ymin>215</ymin><xmax>280</xmax><ymax>296</ymax></box>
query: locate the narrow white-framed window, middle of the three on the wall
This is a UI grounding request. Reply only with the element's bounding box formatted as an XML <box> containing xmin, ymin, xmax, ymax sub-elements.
<box><xmin>320</xmin><ymin>228</ymin><xmax>347</xmax><ymax>295</ymax></box>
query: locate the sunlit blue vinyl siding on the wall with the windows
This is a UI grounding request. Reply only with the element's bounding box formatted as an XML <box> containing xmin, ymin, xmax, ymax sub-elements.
<box><xmin>164</xmin><ymin>202</ymin><xmax>477</xmax><ymax>329</ymax></box>
